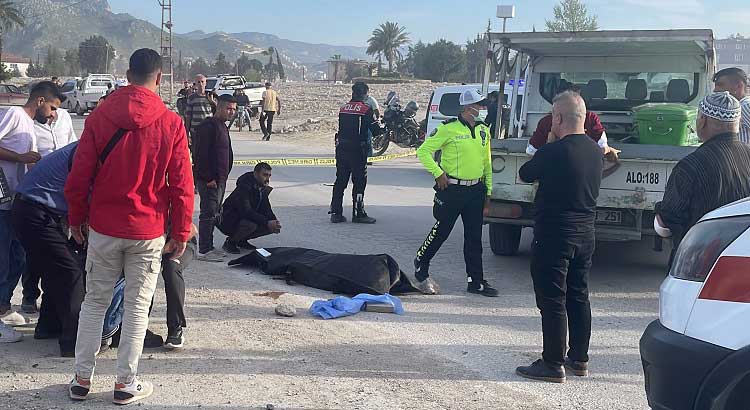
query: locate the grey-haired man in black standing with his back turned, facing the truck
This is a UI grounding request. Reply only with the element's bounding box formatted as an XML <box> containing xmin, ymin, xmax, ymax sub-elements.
<box><xmin>516</xmin><ymin>91</ymin><xmax>603</xmax><ymax>383</ymax></box>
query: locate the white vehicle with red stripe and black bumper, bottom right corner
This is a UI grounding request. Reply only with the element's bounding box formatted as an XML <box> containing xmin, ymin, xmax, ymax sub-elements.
<box><xmin>640</xmin><ymin>198</ymin><xmax>750</xmax><ymax>410</ymax></box>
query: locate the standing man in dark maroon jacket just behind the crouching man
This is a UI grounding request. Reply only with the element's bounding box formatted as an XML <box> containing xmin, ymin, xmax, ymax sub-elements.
<box><xmin>193</xmin><ymin>95</ymin><xmax>237</xmax><ymax>262</ymax></box>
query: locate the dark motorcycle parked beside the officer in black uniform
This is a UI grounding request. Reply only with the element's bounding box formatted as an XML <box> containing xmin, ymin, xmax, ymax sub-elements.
<box><xmin>372</xmin><ymin>91</ymin><xmax>426</xmax><ymax>156</ymax></box>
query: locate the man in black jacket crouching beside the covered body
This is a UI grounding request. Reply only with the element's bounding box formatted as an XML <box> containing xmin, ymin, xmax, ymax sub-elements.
<box><xmin>217</xmin><ymin>162</ymin><xmax>281</xmax><ymax>254</ymax></box>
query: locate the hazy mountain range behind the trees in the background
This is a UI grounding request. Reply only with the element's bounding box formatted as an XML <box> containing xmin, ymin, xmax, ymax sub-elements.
<box><xmin>3</xmin><ymin>0</ymin><xmax>366</xmax><ymax>78</ymax></box>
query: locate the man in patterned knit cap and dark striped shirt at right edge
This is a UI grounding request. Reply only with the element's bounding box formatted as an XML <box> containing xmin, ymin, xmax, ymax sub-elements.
<box><xmin>654</xmin><ymin>91</ymin><xmax>750</xmax><ymax>265</ymax></box>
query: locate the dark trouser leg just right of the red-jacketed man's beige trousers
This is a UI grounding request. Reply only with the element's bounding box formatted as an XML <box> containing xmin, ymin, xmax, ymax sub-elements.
<box><xmin>158</xmin><ymin>244</ymin><xmax>195</xmax><ymax>332</ymax></box>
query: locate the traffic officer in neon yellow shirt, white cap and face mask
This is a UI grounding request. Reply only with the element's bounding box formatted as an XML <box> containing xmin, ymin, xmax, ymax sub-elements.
<box><xmin>414</xmin><ymin>89</ymin><xmax>498</xmax><ymax>297</ymax></box>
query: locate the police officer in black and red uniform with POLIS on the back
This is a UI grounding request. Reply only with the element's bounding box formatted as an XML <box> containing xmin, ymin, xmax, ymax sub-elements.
<box><xmin>329</xmin><ymin>81</ymin><xmax>382</xmax><ymax>224</ymax></box>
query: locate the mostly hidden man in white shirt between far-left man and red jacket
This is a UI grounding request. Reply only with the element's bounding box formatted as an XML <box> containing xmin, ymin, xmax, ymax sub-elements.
<box><xmin>21</xmin><ymin>109</ymin><xmax>78</xmax><ymax>313</ymax></box>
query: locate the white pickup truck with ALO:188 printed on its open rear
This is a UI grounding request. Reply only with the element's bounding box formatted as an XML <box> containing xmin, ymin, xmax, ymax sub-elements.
<box><xmin>483</xmin><ymin>30</ymin><xmax>715</xmax><ymax>255</ymax></box>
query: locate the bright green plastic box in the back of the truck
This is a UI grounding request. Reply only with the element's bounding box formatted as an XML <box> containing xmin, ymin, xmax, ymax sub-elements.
<box><xmin>633</xmin><ymin>103</ymin><xmax>700</xmax><ymax>146</ymax></box>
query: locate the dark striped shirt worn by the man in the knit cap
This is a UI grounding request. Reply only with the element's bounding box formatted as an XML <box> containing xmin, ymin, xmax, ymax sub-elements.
<box><xmin>655</xmin><ymin>133</ymin><xmax>750</xmax><ymax>245</ymax></box>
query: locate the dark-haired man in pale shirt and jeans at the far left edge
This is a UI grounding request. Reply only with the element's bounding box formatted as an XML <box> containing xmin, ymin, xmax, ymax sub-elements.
<box><xmin>0</xmin><ymin>81</ymin><xmax>65</xmax><ymax>343</ymax></box>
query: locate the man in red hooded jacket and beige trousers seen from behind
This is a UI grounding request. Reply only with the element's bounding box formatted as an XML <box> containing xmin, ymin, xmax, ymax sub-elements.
<box><xmin>65</xmin><ymin>49</ymin><xmax>194</xmax><ymax>404</ymax></box>
